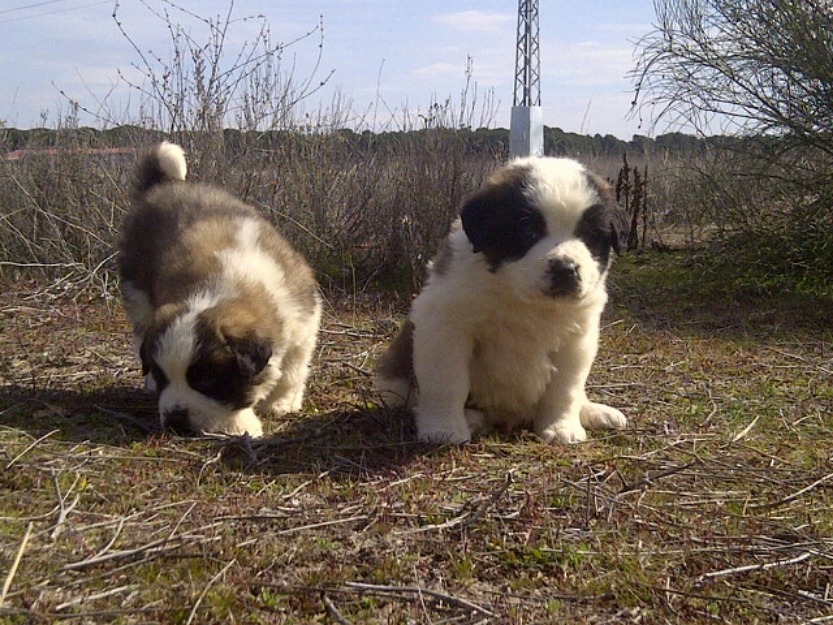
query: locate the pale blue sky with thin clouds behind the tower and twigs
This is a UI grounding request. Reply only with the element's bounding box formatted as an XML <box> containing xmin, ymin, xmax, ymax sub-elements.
<box><xmin>0</xmin><ymin>0</ymin><xmax>654</xmax><ymax>139</ymax></box>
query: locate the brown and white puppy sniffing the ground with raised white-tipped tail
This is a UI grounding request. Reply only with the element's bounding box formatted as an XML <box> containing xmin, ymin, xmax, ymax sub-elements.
<box><xmin>118</xmin><ymin>143</ymin><xmax>321</xmax><ymax>436</ymax></box>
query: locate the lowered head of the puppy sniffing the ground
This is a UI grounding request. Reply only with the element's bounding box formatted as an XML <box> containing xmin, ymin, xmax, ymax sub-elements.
<box><xmin>140</xmin><ymin>298</ymin><xmax>278</xmax><ymax>435</ymax></box>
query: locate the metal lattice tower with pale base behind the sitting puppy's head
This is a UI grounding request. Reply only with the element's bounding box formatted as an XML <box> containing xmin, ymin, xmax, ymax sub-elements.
<box><xmin>509</xmin><ymin>0</ymin><xmax>544</xmax><ymax>156</ymax></box>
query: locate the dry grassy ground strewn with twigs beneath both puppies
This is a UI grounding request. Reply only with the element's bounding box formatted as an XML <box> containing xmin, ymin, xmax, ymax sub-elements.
<box><xmin>0</xmin><ymin>254</ymin><xmax>833</xmax><ymax>625</ymax></box>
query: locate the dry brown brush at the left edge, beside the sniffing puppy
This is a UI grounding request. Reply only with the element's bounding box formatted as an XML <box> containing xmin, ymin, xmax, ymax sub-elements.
<box><xmin>0</xmin><ymin>128</ymin><xmax>134</xmax><ymax>284</ymax></box>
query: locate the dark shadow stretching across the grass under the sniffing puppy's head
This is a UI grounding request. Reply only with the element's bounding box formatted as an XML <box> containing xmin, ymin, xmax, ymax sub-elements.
<box><xmin>0</xmin><ymin>386</ymin><xmax>430</xmax><ymax>479</ymax></box>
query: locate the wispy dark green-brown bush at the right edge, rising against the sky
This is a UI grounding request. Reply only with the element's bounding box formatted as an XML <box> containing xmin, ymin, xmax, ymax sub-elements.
<box><xmin>633</xmin><ymin>0</ymin><xmax>833</xmax><ymax>292</ymax></box>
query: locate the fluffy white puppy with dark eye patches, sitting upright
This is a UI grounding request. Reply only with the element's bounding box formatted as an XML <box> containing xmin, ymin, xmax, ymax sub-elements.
<box><xmin>376</xmin><ymin>157</ymin><xmax>627</xmax><ymax>443</ymax></box>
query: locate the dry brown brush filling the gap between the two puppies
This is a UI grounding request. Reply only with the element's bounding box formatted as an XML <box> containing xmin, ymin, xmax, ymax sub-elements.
<box><xmin>218</xmin><ymin>129</ymin><xmax>496</xmax><ymax>289</ymax></box>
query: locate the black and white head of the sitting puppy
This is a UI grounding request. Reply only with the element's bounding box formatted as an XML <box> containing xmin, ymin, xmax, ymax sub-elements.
<box><xmin>460</xmin><ymin>157</ymin><xmax>627</xmax><ymax>300</ymax></box>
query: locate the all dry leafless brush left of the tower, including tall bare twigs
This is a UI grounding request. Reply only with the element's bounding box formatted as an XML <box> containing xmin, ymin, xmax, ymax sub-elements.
<box><xmin>0</xmin><ymin>3</ymin><xmax>495</xmax><ymax>288</ymax></box>
